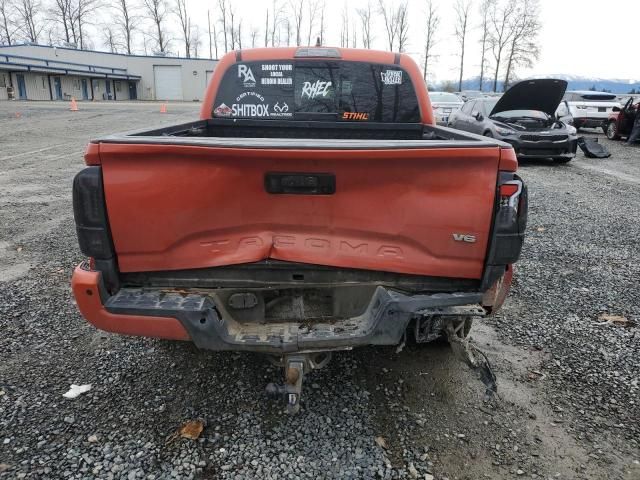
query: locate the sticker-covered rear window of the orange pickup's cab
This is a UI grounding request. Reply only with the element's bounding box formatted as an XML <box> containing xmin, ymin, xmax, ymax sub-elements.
<box><xmin>212</xmin><ymin>60</ymin><xmax>420</xmax><ymax>123</ymax></box>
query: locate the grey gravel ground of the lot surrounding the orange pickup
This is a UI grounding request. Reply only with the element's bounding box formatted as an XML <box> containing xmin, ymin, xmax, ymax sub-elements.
<box><xmin>0</xmin><ymin>102</ymin><xmax>640</xmax><ymax>480</ymax></box>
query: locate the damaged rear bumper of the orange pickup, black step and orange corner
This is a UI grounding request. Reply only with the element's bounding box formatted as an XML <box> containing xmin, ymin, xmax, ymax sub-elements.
<box><xmin>72</xmin><ymin>265</ymin><xmax>502</xmax><ymax>354</ymax></box>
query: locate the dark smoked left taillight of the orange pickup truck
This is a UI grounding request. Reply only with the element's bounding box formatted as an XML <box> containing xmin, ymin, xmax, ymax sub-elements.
<box><xmin>73</xmin><ymin>167</ymin><xmax>113</xmax><ymax>260</ymax></box>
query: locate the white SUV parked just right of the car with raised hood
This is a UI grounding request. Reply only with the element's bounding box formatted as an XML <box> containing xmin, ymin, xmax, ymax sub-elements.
<box><xmin>556</xmin><ymin>90</ymin><xmax>620</xmax><ymax>131</ymax></box>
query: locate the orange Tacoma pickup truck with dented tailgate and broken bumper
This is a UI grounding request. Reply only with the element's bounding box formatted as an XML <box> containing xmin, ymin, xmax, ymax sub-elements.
<box><xmin>72</xmin><ymin>47</ymin><xmax>527</xmax><ymax>411</ymax></box>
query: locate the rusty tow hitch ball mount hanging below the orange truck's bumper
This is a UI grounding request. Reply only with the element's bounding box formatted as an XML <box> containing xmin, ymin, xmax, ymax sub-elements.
<box><xmin>266</xmin><ymin>352</ymin><xmax>331</xmax><ymax>414</ymax></box>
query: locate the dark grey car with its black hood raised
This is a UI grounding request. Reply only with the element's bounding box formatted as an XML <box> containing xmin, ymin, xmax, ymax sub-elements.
<box><xmin>449</xmin><ymin>79</ymin><xmax>578</xmax><ymax>163</ymax></box>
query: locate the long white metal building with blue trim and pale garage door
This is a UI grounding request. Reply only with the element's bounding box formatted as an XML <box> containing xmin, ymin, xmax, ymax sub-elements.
<box><xmin>0</xmin><ymin>44</ymin><xmax>217</xmax><ymax>101</ymax></box>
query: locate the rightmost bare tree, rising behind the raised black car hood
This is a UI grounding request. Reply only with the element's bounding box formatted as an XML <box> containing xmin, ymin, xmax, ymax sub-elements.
<box><xmin>504</xmin><ymin>0</ymin><xmax>540</xmax><ymax>91</ymax></box>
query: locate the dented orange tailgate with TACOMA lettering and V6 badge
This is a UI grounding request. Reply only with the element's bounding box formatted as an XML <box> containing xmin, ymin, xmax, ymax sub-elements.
<box><xmin>100</xmin><ymin>142</ymin><xmax>500</xmax><ymax>279</ymax></box>
